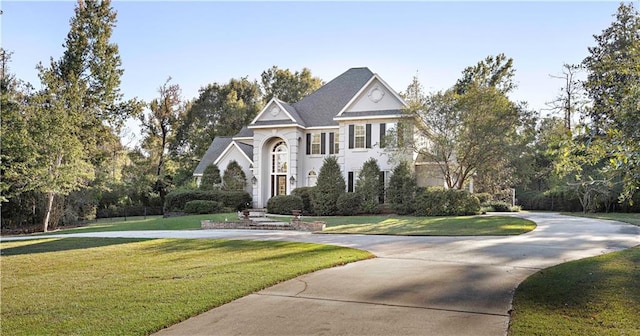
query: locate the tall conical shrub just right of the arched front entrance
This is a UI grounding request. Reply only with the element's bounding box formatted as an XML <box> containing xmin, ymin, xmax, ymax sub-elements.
<box><xmin>312</xmin><ymin>156</ymin><xmax>346</xmax><ymax>216</ymax></box>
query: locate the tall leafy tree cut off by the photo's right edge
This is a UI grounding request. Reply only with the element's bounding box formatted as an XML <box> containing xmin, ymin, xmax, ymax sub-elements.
<box><xmin>582</xmin><ymin>3</ymin><xmax>640</xmax><ymax>200</ymax></box>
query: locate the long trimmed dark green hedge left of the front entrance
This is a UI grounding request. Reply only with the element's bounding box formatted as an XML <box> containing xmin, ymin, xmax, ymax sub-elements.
<box><xmin>164</xmin><ymin>190</ymin><xmax>252</xmax><ymax>211</ymax></box>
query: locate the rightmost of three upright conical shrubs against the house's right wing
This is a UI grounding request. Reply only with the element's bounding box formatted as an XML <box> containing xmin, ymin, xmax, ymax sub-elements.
<box><xmin>387</xmin><ymin>161</ymin><xmax>416</xmax><ymax>215</ymax></box>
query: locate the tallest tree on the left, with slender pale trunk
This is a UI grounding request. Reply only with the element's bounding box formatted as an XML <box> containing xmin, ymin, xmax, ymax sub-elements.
<box><xmin>2</xmin><ymin>1</ymin><xmax>140</xmax><ymax>231</ymax></box>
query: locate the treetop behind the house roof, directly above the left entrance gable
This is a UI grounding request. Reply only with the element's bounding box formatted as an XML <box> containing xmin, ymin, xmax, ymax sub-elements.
<box><xmin>261</xmin><ymin>65</ymin><xmax>323</xmax><ymax>104</ymax></box>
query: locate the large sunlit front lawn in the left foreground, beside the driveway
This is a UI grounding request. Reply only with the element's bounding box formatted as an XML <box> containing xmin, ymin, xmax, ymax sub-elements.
<box><xmin>0</xmin><ymin>238</ymin><xmax>372</xmax><ymax>335</ymax></box>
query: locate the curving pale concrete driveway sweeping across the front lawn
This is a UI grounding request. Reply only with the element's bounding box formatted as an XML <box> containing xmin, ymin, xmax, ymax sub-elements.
<box><xmin>3</xmin><ymin>213</ymin><xmax>640</xmax><ymax>336</ymax></box>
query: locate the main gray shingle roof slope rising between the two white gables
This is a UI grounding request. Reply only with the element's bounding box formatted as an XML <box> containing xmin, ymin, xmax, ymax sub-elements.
<box><xmin>293</xmin><ymin>68</ymin><xmax>374</xmax><ymax>127</ymax></box>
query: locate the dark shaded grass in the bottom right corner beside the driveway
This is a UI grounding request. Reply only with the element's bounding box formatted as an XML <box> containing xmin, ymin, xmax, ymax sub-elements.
<box><xmin>509</xmin><ymin>246</ymin><xmax>640</xmax><ymax>336</ymax></box>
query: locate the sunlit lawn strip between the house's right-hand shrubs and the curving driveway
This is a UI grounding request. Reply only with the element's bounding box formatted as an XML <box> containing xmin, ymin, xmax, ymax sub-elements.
<box><xmin>318</xmin><ymin>216</ymin><xmax>536</xmax><ymax>236</ymax></box>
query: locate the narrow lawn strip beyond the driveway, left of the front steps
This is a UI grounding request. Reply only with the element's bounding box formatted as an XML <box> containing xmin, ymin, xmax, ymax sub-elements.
<box><xmin>34</xmin><ymin>213</ymin><xmax>238</xmax><ymax>235</ymax></box>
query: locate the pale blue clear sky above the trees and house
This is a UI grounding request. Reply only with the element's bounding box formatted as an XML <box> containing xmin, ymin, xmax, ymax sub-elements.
<box><xmin>0</xmin><ymin>1</ymin><xmax>624</xmax><ymax>146</ymax></box>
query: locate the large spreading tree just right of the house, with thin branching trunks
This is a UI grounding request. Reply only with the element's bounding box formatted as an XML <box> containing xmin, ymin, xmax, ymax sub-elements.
<box><xmin>406</xmin><ymin>55</ymin><xmax>534</xmax><ymax>189</ymax></box>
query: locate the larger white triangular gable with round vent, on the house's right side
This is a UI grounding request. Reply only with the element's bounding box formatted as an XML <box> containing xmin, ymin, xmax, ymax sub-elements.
<box><xmin>342</xmin><ymin>79</ymin><xmax>403</xmax><ymax>116</ymax></box>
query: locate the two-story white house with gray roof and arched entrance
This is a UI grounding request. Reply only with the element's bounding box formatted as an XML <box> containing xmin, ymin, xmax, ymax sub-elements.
<box><xmin>193</xmin><ymin>68</ymin><xmax>440</xmax><ymax>208</ymax></box>
